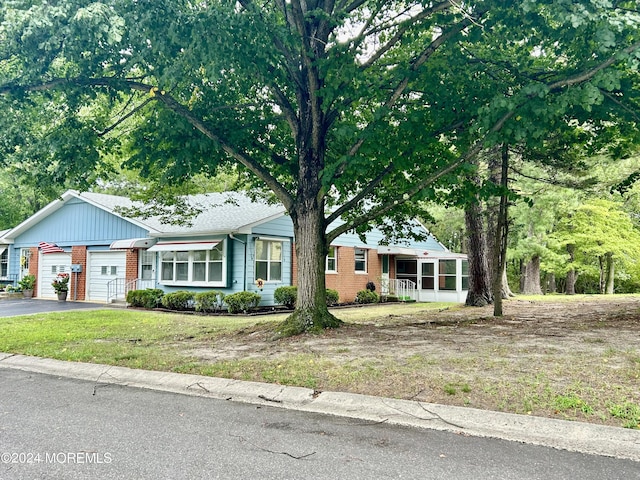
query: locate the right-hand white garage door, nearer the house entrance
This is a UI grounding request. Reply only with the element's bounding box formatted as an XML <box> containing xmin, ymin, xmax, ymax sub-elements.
<box><xmin>87</xmin><ymin>252</ymin><xmax>126</xmax><ymax>302</ymax></box>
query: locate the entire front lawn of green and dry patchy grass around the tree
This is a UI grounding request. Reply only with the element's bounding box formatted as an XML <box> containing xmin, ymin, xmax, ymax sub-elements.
<box><xmin>0</xmin><ymin>296</ymin><xmax>640</xmax><ymax>428</ymax></box>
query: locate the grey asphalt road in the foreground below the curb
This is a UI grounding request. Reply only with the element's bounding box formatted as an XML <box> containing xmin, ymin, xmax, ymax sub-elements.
<box><xmin>0</xmin><ymin>368</ymin><xmax>640</xmax><ymax>480</ymax></box>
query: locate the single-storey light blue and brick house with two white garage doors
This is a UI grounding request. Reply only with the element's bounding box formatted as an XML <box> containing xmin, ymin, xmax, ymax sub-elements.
<box><xmin>0</xmin><ymin>190</ymin><xmax>468</xmax><ymax>305</ymax></box>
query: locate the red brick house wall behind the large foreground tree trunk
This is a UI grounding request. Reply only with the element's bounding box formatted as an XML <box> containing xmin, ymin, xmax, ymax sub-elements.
<box><xmin>292</xmin><ymin>247</ymin><xmax>382</xmax><ymax>302</ymax></box>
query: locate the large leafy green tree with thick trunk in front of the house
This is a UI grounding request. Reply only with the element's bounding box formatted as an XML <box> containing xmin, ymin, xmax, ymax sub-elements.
<box><xmin>0</xmin><ymin>0</ymin><xmax>640</xmax><ymax>331</ymax></box>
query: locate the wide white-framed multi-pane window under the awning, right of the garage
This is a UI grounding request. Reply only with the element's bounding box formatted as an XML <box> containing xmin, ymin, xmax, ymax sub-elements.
<box><xmin>159</xmin><ymin>243</ymin><xmax>226</xmax><ymax>287</ymax></box>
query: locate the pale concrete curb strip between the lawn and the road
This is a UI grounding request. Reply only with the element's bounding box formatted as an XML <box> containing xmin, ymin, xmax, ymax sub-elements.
<box><xmin>0</xmin><ymin>353</ymin><xmax>640</xmax><ymax>462</ymax></box>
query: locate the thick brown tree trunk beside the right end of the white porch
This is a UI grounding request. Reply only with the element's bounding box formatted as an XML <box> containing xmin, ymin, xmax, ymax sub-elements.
<box><xmin>464</xmin><ymin>203</ymin><xmax>493</xmax><ymax>307</ymax></box>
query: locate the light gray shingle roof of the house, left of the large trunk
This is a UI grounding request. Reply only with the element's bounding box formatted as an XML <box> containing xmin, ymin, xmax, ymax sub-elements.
<box><xmin>79</xmin><ymin>192</ymin><xmax>285</xmax><ymax>235</ymax></box>
